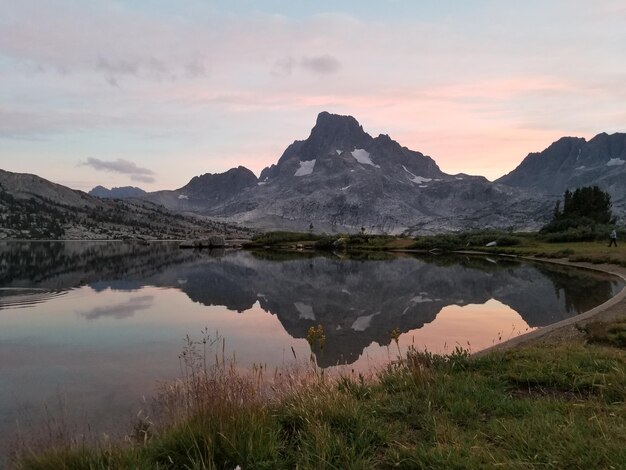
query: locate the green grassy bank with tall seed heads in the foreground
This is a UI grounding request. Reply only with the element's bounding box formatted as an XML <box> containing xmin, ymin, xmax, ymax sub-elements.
<box><xmin>17</xmin><ymin>318</ymin><xmax>626</xmax><ymax>469</ymax></box>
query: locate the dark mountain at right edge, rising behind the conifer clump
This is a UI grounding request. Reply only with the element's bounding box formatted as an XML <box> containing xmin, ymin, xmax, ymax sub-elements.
<box><xmin>496</xmin><ymin>133</ymin><xmax>626</xmax><ymax>215</ymax></box>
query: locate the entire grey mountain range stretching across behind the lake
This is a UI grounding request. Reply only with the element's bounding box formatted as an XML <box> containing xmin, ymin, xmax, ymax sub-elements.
<box><xmin>0</xmin><ymin>112</ymin><xmax>626</xmax><ymax>237</ymax></box>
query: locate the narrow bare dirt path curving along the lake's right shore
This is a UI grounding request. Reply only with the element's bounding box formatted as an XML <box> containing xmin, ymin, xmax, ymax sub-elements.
<box><xmin>475</xmin><ymin>257</ymin><xmax>626</xmax><ymax>356</ymax></box>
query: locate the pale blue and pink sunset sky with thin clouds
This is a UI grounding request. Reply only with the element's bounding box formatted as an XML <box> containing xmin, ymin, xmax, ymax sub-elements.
<box><xmin>0</xmin><ymin>0</ymin><xmax>626</xmax><ymax>190</ymax></box>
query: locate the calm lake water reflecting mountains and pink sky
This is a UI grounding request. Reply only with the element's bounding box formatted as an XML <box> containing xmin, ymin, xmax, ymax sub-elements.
<box><xmin>0</xmin><ymin>242</ymin><xmax>623</xmax><ymax>452</ymax></box>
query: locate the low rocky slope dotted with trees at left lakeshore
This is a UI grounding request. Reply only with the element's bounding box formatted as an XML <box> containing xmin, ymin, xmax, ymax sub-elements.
<box><xmin>0</xmin><ymin>170</ymin><xmax>254</xmax><ymax>239</ymax></box>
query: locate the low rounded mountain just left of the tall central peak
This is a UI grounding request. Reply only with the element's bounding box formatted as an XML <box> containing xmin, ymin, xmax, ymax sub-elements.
<box><xmin>144</xmin><ymin>166</ymin><xmax>258</xmax><ymax>212</ymax></box>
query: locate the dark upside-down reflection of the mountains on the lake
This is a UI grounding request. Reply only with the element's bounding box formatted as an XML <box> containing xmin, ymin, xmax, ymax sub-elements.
<box><xmin>0</xmin><ymin>242</ymin><xmax>621</xmax><ymax>367</ymax></box>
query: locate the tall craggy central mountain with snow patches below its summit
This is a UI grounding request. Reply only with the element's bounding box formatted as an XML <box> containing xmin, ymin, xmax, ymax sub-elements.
<box><xmin>148</xmin><ymin>112</ymin><xmax>552</xmax><ymax>234</ymax></box>
